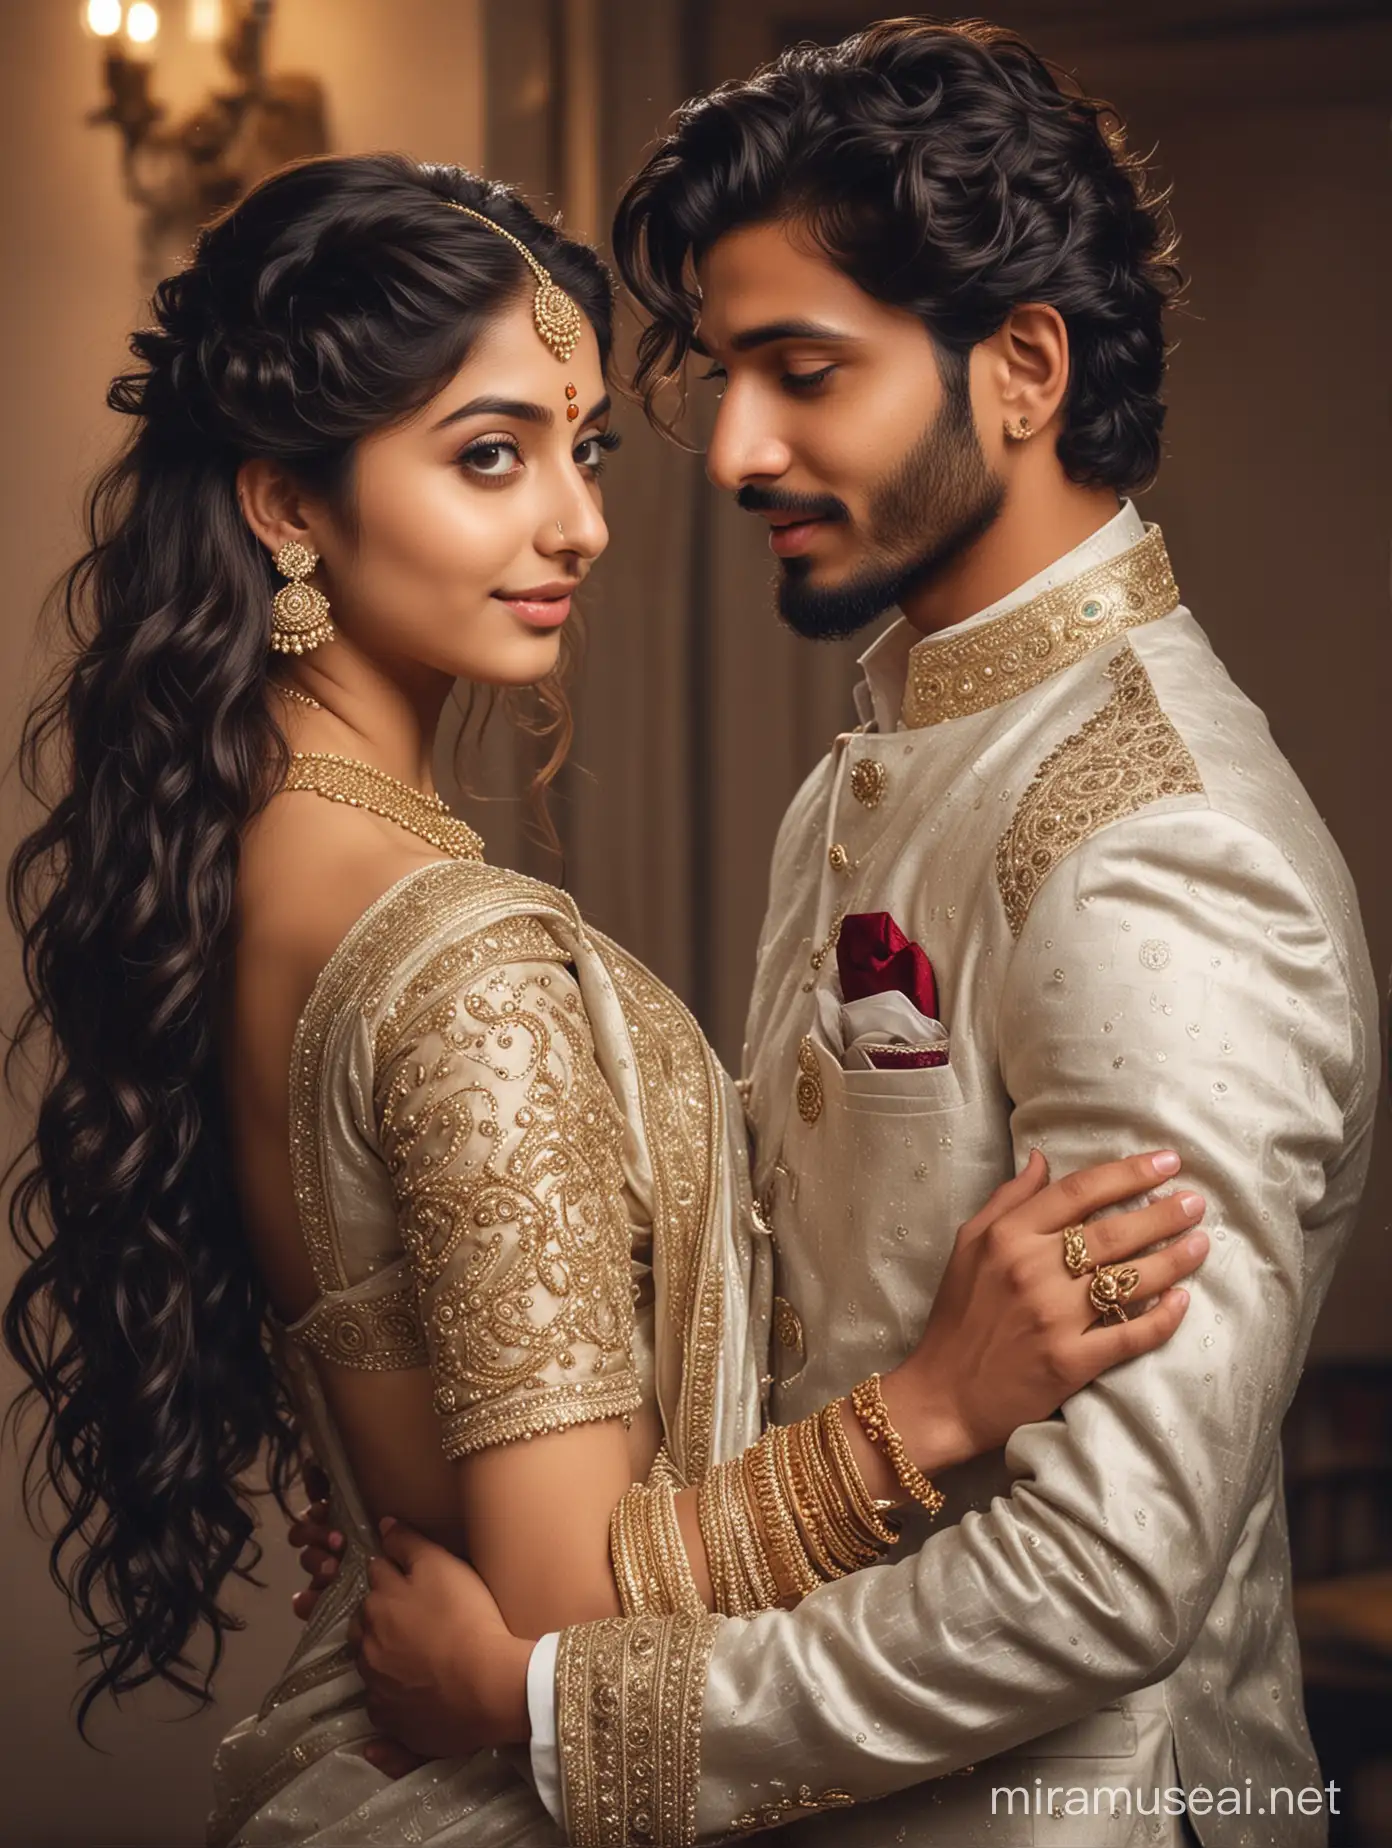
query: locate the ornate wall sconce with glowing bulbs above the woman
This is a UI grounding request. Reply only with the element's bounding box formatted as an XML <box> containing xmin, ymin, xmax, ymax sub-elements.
<box><xmin>83</xmin><ymin>0</ymin><xmax>329</xmax><ymax>286</ymax></box>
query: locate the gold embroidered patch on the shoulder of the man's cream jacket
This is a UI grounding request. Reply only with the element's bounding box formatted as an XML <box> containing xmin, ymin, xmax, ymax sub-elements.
<box><xmin>996</xmin><ymin>645</ymin><xmax>1203</xmax><ymax>937</ymax></box>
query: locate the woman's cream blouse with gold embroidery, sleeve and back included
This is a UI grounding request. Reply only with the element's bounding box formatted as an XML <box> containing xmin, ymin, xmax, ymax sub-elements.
<box><xmin>290</xmin><ymin>881</ymin><xmax>651</xmax><ymax>1458</ymax></box>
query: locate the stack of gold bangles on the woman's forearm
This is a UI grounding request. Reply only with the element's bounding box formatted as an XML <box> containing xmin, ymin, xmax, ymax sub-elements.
<box><xmin>610</xmin><ymin>1373</ymin><xmax>943</xmax><ymax>1617</ymax></box>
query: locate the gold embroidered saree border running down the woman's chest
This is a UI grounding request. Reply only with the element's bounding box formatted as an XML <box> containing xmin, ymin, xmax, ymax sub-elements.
<box><xmin>595</xmin><ymin>933</ymin><xmax>725</xmax><ymax>1484</ymax></box>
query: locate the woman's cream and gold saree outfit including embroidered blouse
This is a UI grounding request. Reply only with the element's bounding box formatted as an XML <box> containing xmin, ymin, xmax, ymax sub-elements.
<box><xmin>207</xmin><ymin>861</ymin><xmax>769</xmax><ymax>1848</ymax></box>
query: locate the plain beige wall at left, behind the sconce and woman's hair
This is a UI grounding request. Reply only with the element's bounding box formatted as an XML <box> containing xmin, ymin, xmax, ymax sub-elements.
<box><xmin>0</xmin><ymin>0</ymin><xmax>482</xmax><ymax>1848</ymax></box>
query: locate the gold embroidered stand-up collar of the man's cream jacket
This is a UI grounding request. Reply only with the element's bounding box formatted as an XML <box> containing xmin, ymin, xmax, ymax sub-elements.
<box><xmin>902</xmin><ymin>527</ymin><xmax>1179</xmax><ymax>730</ymax></box>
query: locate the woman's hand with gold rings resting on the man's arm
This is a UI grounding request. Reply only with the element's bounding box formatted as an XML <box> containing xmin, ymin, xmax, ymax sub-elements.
<box><xmin>884</xmin><ymin>1149</ymin><xmax>1209</xmax><ymax>1473</ymax></box>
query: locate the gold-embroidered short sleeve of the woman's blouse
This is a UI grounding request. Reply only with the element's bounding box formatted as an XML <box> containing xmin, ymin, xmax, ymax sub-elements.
<box><xmin>377</xmin><ymin>938</ymin><xmax>640</xmax><ymax>1456</ymax></box>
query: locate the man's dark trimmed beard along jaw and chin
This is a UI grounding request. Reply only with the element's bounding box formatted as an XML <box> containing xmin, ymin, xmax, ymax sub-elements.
<box><xmin>754</xmin><ymin>368</ymin><xmax>1006</xmax><ymax>641</ymax></box>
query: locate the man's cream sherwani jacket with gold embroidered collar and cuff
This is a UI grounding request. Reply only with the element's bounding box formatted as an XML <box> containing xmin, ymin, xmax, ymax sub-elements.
<box><xmin>543</xmin><ymin>506</ymin><xmax>1375</xmax><ymax>1848</ymax></box>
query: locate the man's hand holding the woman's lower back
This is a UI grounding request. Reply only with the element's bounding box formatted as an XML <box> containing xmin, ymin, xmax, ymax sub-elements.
<box><xmin>348</xmin><ymin>1519</ymin><xmax>532</xmax><ymax>1776</ymax></box>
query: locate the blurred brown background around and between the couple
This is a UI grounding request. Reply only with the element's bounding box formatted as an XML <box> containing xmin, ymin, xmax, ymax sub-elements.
<box><xmin>0</xmin><ymin>0</ymin><xmax>1392</xmax><ymax>1848</ymax></box>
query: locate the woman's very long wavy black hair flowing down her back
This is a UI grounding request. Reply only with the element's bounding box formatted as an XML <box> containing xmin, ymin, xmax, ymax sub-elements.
<box><xmin>4</xmin><ymin>155</ymin><xmax>612</xmax><ymax>1724</ymax></box>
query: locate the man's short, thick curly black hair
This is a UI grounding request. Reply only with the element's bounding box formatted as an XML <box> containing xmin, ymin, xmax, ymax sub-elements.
<box><xmin>614</xmin><ymin>18</ymin><xmax>1181</xmax><ymax>492</ymax></box>
